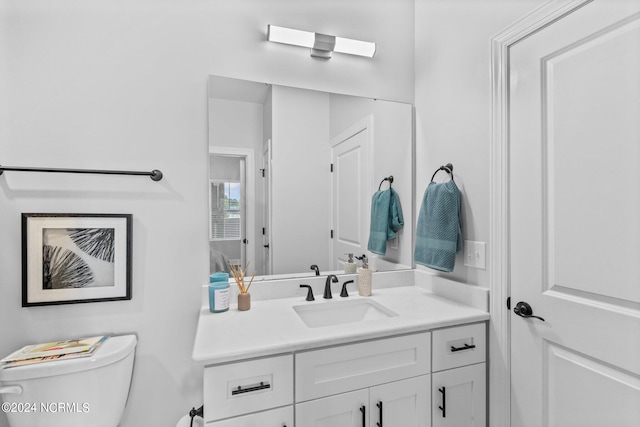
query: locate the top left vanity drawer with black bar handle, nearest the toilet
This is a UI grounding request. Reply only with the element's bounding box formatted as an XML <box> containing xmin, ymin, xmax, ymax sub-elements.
<box><xmin>204</xmin><ymin>354</ymin><xmax>293</xmax><ymax>422</ymax></box>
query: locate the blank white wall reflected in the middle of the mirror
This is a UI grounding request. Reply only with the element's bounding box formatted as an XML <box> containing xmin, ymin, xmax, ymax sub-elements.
<box><xmin>270</xmin><ymin>86</ymin><xmax>331</xmax><ymax>274</ymax></box>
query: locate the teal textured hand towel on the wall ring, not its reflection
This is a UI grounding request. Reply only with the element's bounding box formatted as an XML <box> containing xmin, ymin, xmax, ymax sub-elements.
<box><xmin>413</xmin><ymin>180</ymin><xmax>462</xmax><ymax>272</ymax></box>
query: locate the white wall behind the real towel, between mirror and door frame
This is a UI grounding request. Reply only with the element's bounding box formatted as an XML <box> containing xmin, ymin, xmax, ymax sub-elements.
<box><xmin>415</xmin><ymin>0</ymin><xmax>546</xmax><ymax>287</ymax></box>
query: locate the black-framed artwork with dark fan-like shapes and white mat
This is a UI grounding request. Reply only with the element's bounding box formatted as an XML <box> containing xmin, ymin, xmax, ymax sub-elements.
<box><xmin>22</xmin><ymin>213</ymin><xmax>132</xmax><ymax>307</ymax></box>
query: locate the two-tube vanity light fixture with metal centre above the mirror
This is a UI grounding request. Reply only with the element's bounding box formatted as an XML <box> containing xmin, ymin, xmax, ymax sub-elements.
<box><xmin>267</xmin><ymin>25</ymin><xmax>376</xmax><ymax>59</ymax></box>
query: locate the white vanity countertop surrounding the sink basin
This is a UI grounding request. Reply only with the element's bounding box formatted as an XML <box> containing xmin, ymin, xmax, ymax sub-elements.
<box><xmin>192</xmin><ymin>286</ymin><xmax>489</xmax><ymax>365</ymax></box>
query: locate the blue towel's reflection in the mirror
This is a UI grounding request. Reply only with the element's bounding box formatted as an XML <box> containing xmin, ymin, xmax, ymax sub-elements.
<box><xmin>367</xmin><ymin>188</ymin><xmax>404</xmax><ymax>255</ymax></box>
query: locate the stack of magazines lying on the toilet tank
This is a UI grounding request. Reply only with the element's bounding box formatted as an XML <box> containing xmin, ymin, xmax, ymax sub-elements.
<box><xmin>0</xmin><ymin>335</ymin><xmax>109</xmax><ymax>369</ymax></box>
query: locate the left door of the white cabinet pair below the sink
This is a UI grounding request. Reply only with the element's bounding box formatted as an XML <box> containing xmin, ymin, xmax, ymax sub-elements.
<box><xmin>296</xmin><ymin>389</ymin><xmax>369</xmax><ymax>427</ymax></box>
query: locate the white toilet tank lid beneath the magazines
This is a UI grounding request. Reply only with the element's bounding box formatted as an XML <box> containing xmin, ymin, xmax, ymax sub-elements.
<box><xmin>0</xmin><ymin>335</ymin><xmax>137</xmax><ymax>382</ymax></box>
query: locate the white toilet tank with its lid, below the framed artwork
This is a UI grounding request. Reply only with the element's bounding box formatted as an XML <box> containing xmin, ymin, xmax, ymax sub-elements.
<box><xmin>0</xmin><ymin>335</ymin><xmax>137</xmax><ymax>427</ymax></box>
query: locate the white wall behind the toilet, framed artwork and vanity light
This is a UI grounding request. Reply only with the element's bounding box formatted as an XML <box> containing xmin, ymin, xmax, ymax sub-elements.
<box><xmin>0</xmin><ymin>0</ymin><xmax>414</xmax><ymax>427</ymax></box>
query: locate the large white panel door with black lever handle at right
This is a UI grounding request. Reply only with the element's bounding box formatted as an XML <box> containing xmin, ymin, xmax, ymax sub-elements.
<box><xmin>509</xmin><ymin>0</ymin><xmax>640</xmax><ymax>427</ymax></box>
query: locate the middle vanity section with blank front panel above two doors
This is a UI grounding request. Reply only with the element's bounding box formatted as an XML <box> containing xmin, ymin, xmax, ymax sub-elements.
<box><xmin>295</xmin><ymin>332</ymin><xmax>431</xmax><ymax>427</ymax></box>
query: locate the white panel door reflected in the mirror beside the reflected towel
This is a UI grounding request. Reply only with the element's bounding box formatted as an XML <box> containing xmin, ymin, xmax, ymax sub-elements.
<box><xmin>330</xmin><ymin>117</ymin><xmax>373</xmax><ymax>270</ymax></box>
